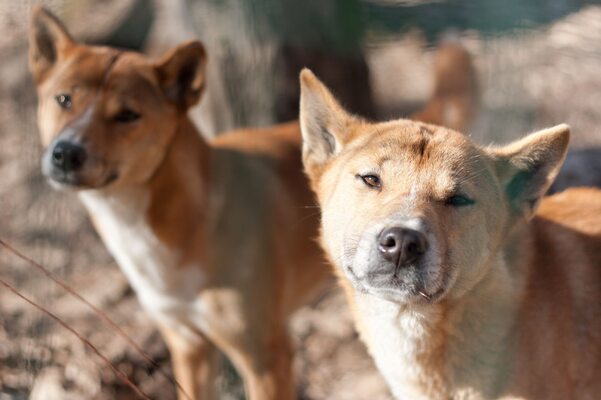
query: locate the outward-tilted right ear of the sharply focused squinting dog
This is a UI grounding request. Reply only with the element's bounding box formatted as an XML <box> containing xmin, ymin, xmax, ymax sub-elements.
<box><xmin>494</xmin><ymin>124</ymin><xmax>570</xmax><ymax>219</ymax></box>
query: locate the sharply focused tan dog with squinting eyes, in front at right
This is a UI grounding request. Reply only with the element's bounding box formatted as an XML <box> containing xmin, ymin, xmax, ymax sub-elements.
<box><xmin>301</xmin><ymin>71</ymin><xmax>601</xmax><ymax>400</ymax></box>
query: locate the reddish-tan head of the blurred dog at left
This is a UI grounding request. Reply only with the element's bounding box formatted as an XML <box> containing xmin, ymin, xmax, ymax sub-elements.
<box><xmin>29</xmin><ymin>8</ymin><xmax>206</xmax><ymax>188</ymax></box>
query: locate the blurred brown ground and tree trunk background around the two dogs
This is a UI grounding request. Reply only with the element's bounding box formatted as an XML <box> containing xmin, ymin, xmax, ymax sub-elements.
<box><xmin>0</xmin><ymin>0</ymin><xmax>601</xmax><ymax>400</ymax></box>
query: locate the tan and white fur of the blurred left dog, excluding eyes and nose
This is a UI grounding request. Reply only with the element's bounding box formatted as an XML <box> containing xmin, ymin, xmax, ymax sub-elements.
<box><xmin>30</xmin><ymin>9</ymin><xmax>330</xmax><ymax>400</ymax></box>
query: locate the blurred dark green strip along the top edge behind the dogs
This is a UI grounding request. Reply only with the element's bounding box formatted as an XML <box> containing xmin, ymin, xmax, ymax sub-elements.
<box><xmin>196</xmin><ymin>0</ymin><xmax>599</xmax><ymax>53</ymax></box>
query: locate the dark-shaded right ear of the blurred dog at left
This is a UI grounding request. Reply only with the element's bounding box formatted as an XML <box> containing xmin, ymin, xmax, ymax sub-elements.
<box><xmin>156</xmin><ymin>40</ymin><xmax>207</xmax><ymax>110</ymax></box>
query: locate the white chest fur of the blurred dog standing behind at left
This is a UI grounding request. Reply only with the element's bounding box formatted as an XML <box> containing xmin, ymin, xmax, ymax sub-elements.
<box><xmin>80</xmin><ymin>188</ymin><xmax>205</xmax><ymax>334</ymax></box>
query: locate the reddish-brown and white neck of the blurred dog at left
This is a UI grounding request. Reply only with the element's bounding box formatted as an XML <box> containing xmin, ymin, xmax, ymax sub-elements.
<box><xmin>80</xmin><ymin>116</ymin><xmax>211</xmax><ymax>262</ymax></box>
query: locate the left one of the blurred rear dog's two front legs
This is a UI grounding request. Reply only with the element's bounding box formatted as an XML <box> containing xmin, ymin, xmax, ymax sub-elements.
<box><xmin>159</xmin><ymin>325</ymin><xmax>218</xmax><ymax>400</ymax></box>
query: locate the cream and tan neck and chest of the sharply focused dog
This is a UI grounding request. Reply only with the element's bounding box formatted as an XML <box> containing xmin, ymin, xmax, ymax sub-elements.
<box><xmin>352</xmin><ymin>253</ymin><xmax>519</xmax><ymax>399</ymax></box>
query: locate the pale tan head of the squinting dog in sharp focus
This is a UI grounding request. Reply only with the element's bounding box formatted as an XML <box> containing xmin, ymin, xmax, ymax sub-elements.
<box><xmin>300</xmin><ymin>70</ymin><xmax>569</xmax><ymax>303</ymax></box>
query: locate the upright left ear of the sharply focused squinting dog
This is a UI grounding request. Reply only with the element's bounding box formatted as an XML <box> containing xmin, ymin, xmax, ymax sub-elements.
<box><xmin>299</xmin><ymin>68</ymin><xmax>355</xmax><ymax>174</ymax></box>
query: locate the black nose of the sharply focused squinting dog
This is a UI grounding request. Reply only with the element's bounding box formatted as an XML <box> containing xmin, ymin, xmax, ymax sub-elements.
<box><xmin>378</xmin><ymin>227</ymin><xmax>428</xmax><ymax>267</ymax></box>
